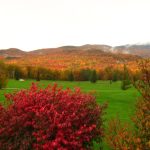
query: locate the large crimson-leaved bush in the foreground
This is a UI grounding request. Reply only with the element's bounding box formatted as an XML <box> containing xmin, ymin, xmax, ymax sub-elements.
<box><xmin>0</xmin><ymin>84</ymin><xmax>104</xmax><ymax>150</ymax></box>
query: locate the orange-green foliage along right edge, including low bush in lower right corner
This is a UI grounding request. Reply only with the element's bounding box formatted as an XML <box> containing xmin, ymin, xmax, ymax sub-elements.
<box><xmin>106</xmin><ymin>59</ymin><xmax>150</xmax><ymax>150</ymax></box>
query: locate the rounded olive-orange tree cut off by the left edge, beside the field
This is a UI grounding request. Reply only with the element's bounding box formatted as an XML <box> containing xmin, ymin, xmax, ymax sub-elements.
<box><xmin>0</xmin><ymin>62</ymin><xmax>8</xmax><ymax>89</ymax></box>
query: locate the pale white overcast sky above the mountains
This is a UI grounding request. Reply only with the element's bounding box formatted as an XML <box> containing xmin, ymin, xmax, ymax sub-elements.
<box><xmin>0</xmin><ymin>0</ymin><xmax>150</xmax><ymax>51</ymax></box>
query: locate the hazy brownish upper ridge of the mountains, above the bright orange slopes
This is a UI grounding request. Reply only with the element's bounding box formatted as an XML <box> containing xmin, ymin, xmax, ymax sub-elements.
<box><xmin>0</xmin><ymin>44</ymin><xmax>150</xmax><ymax>59</ymax></box>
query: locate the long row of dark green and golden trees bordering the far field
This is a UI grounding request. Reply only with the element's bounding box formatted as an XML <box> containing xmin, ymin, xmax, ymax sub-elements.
<box><xmin>7</xmin><ymin>65</ymin><xmax>140</xmax><ymax>84</ymax></box>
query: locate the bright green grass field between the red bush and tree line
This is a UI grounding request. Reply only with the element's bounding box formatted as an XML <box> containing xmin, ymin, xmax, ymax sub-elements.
<box><xmin>0</xmin><ymin>80</ymin><xmax>139</xmax><ymax>149</ymax></box>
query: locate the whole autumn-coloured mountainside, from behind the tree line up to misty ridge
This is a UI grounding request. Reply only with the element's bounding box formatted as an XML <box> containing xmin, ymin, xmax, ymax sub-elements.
<box><xmin>0</xmin><ymin>44</ymin><xmax>150</xmax><ymax>70</ymax></box>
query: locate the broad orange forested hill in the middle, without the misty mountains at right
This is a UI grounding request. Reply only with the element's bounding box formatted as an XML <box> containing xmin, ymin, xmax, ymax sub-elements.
<box><xmin>3</xmin><ymin>45</ymin><xmax>140</xmax><ymax>70</ymax></box>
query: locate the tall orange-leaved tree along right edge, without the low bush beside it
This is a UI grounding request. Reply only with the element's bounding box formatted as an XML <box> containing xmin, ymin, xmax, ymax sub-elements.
<box><xmin>133</xmin><ymin>59</ymin><xmax>150</xmax><ymax>150</ymax></box>
